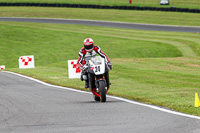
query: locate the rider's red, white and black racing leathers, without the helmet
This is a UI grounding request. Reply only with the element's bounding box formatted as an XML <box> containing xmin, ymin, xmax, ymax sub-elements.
<box><xmin>77</xmin><ymin>45</ymin><xmax>112</xmax><ymax>88</ymax></box>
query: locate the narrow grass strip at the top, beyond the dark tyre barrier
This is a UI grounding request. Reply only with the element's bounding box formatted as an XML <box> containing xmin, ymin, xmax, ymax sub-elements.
<box><xmin>0</xmin><ymin>0</ymin><xmax>200</xmax><ymax>9</ymax></box>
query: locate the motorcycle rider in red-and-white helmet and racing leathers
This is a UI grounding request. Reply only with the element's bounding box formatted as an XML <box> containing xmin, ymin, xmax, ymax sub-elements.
<box><xmin>77</xmin><ymin>38</ymin><xmax>112</xmax><ymax>88</ymax></box>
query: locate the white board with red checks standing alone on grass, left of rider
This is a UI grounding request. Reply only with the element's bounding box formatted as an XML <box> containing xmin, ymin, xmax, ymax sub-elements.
<box><xmin>18</xmin><ymin>55</ymin><xmax>35</xmax><ymax>68</ymax></box>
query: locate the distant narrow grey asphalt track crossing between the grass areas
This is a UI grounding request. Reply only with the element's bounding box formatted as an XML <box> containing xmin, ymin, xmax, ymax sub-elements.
<box><xmin>0</xmin><ymin>17</ymin><xmax>200</xmax><ymax>33</ymax></box>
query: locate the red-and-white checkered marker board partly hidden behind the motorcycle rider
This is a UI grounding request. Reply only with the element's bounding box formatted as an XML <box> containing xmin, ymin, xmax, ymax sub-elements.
<box><xmin>68</xmin><ymin>60</ymin><xmax>81</xmax><ymax>78</ymax></box>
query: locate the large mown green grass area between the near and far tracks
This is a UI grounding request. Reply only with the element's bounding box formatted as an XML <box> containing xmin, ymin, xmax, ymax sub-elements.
<box><xmin>0</xmin><ymin>15</ymin><xmax>200</xmax><ymax>116</ymax></box>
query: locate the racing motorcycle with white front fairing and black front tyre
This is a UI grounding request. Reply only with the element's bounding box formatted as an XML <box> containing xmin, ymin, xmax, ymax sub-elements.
<box><xmin>83</xmin><ymin>56</ymin><xmax>111</xmax><ymax>102</ymax></box>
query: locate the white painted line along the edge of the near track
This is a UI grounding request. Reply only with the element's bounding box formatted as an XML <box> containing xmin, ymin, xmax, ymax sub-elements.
<box><xmin>1</xmin><ymin>71</ymin><xmax>200</xmax><ymax>120</ymax></box>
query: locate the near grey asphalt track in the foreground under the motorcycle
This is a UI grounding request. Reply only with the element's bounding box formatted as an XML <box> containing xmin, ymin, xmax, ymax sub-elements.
<box><xmin>0</xmin><ymin>72</ymin><xmax>200</xmax><ymax>133</ymax></box>
